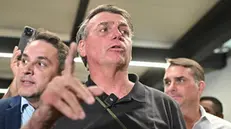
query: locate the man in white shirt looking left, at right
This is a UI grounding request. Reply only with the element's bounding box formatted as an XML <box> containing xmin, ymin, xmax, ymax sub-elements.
<box><xmin>163</xmin><ymin>58</ymin><xmax>231</xmax><ymax>129</ymax></box>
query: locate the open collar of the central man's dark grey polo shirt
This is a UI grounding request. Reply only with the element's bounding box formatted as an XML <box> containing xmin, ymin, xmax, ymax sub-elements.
<box><xmin>86</xmin><ymin>74</ymin><xmax>145</xmax><ymax>102</ymax></box>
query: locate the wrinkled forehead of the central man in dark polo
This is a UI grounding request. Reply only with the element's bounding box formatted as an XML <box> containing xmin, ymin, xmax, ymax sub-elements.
<box><xmin>87</xmin><ymin>12</ymin><xmax>129</xmax><ymax>28</ymax></box>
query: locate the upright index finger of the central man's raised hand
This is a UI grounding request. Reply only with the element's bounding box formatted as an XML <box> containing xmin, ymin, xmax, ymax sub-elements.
<box><xmin>62</xmin><ymin>43</ymin><xmax>77</xmax><ymax>75</ymax></box>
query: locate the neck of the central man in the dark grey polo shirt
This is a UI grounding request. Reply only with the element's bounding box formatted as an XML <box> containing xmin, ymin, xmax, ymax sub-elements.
<box><xmin>89</xmin><ymin>63</ymin><xmax>134</xmax><ymax>99</ymax></box>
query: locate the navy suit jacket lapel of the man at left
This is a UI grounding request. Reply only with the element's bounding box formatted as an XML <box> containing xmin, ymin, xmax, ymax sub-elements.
<box><xmin>5</xmin><ymin>96</ymin><xmax>21</xmax><ymax>129</ymax></box>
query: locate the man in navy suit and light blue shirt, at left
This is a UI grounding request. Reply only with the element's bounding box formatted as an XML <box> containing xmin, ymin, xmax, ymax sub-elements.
<box><xmin>0</xmin><ymin>29</ymin><xmax>68</xmax><ymax>129</ymax></box>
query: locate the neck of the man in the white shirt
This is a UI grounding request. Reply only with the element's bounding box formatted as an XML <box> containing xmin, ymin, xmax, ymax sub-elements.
<box><xmin>181</xmin><ymin>104</ymin><xmax>201</xmax><ymax>129</ymax></box>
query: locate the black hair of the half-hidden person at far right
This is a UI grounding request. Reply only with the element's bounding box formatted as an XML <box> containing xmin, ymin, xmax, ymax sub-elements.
<box><xmin>200</xmin><ymin>96</ymin><xmax>223</xmax><ymax>115</ymax></box>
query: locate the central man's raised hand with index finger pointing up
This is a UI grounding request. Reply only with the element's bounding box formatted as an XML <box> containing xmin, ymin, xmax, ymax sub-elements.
<box><xmin>38</xmin><ymin>43</ymin><xmax>102</xmax><ymax>120</ymax></box>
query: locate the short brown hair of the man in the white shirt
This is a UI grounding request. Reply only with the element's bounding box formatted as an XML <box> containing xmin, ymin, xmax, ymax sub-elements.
<box><xmin>167</xmin><ymin>58</ymin><xmax>205</xmax><ymax>81</ymax></box>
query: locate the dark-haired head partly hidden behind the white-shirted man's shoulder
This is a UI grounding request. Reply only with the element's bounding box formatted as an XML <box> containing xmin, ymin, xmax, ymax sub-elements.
<box><xmin>200</xmin><ymin>96</ymin><xmax>224</xmax><ymax>118</ymax></box>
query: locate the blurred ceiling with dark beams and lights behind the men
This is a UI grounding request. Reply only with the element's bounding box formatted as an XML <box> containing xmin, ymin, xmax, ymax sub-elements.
<box><xmin>0</xmin><ymin>0</ymin><xmax>231</xmax><ymax>121</ymax></box>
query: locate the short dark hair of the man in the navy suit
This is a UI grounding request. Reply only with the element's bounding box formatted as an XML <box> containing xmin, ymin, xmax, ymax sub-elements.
<box><xmin>32</xmin><ymin>28</ymin><xmax>69</xmax><ymax>74</ymax></box>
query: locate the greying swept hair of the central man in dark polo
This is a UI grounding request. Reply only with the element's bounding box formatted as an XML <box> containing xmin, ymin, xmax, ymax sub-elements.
<box><xmin>76</xmin><ymin>4</ymin><xmax>133</xmax><ymax>67</ymax></box>
